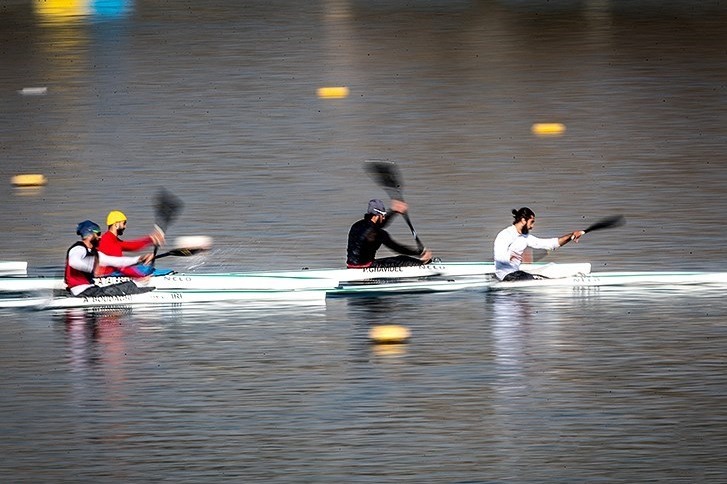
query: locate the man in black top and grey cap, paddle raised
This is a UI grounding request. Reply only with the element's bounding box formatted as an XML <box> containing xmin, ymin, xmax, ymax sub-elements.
<box><xmin>346</xmin><ymin>199</ymin><xmax>432</xmax><ymax>269</ymax></box>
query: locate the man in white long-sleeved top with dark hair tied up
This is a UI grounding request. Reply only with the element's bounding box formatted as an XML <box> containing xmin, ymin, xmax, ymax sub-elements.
<box><xmin>494</xmin><ymin>207</ymin><xmax>585</xmax><ymax>281</ymax></box>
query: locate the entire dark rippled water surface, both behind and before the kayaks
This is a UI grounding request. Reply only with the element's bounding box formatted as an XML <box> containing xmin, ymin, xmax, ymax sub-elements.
<box><xmin>0</xmin><ymin>0</ymin><xmax>727</xmax><ymax>483</ymax></box>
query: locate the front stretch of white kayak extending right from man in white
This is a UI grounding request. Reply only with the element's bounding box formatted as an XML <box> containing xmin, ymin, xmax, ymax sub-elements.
<box><xmin>489</xmin><ymin>272</ymin><xmax>727</xmax><ymax>290</ymax></box>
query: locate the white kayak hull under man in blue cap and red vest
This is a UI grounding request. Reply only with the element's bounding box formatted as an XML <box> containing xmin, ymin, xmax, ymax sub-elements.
<box><xmin>0</xmin><ymin>290</ymin><xmax>326</xmax><ymax>309</ymax></box>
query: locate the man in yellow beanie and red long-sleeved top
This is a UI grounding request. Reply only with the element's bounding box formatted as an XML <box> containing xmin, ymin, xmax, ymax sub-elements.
<box><xmin>96</xmin><ymin>210</ymin><xmax>164</xmax><ymax>277</ymax></box>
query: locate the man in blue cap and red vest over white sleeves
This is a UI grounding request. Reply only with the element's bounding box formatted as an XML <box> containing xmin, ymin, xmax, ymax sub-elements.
<box><xmin>65</xmin><ymin>220</ymin><xmax>154</xmax><ymax>297</ymax></box>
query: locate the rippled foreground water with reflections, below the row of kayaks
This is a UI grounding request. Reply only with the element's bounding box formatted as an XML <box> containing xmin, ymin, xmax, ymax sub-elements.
<box><xmin>0</xmin><ymin>291</ymin><xmax>727</xmax><ymax>482</ymax></box>
